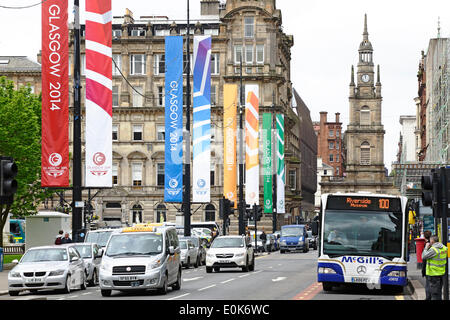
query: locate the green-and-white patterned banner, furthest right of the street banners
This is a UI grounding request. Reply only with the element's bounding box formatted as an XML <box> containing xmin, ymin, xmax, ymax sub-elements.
<box><xmin>276</xmin><ymin>114</ymin><xmax>286</xmax><ymax>214</ymax></box>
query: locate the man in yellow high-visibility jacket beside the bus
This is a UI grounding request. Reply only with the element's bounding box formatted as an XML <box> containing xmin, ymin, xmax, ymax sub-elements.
<box><xmin>422</xmin><ymin>236</ymin><xmax>448</xmax><ymax>300</ymax></box>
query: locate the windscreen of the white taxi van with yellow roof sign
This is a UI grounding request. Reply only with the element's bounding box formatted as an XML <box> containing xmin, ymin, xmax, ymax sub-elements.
<box><xmin>105</xmin><ymin>233</ymin><xmax>163</xmax><ymax>257</ymax></box>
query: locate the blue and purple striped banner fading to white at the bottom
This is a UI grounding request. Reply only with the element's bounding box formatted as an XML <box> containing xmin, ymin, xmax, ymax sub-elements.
<box><xmin>192</xmin><ymin>36</ymin><xmax>211</xmax><ymax>203</ymax></box>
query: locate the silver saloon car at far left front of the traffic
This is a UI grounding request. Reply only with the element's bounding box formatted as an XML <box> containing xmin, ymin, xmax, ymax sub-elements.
<box><xmin>8</xmin><ymin>245</ymin><xmax>86</xmax><ymax>296</ymax></box>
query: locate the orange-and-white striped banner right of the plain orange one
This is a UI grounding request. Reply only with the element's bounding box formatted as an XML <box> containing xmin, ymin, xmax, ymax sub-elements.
<box><xmin>245</xmin><ymin>84</ymin><xmax>259</xmax><ymax>206</ymax></box>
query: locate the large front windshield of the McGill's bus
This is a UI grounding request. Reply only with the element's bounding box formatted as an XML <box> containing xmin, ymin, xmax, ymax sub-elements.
<box><xmin>323</xmin><ymin>210</ymin><xmax>402</xmax><ymax>260</ymax></box>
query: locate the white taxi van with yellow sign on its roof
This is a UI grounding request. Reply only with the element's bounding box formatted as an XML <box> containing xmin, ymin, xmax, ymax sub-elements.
<box><xmin>100</xmin><ymin>226</ymin><xmax>181</xmax><ymax>297</ymax></box>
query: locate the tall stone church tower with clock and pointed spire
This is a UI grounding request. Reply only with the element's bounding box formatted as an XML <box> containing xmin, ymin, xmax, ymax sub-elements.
<box><xmin>346</xmin><ymin>15</ymin><xmax>385</xmax><ymax>181</ymax></box>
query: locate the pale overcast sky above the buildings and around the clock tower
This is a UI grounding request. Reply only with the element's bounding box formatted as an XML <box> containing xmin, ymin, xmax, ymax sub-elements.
<box><xmin>0</xmin><ymin>0</ymin><xmax>450</xmax><ymax>169</ymax></box>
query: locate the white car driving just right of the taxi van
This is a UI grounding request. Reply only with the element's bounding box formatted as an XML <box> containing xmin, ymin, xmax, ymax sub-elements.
<box><xmin>206</xmin><ymin>236</ymin><xmax>255</xmax><ymax>273</ymax></box>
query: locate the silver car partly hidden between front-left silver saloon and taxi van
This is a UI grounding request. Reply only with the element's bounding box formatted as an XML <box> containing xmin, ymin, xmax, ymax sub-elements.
<box><xmin>63</xmin><ymin>243</ymin><xmax>103</xmax><ymax>286</ymax></box>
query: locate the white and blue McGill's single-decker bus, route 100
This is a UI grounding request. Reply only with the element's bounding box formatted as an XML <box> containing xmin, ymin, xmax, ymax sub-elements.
<box><xmin>317</xmin><ymin>193</ymin><xmax>409</xmax><ymax>291</ymax></box>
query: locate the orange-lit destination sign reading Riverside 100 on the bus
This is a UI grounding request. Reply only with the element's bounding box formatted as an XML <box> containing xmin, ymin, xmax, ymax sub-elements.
<box><xmin>327</xmin><ymin>196</ymin><xmax>401</xmax><ymax>212</ymax></box>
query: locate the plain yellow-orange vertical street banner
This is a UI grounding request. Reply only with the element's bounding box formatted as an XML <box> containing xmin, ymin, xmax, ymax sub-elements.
<box><xmin>223</xmin><ymin>84</ymin><xmax>238</xmax><ymax>207</ymax></box>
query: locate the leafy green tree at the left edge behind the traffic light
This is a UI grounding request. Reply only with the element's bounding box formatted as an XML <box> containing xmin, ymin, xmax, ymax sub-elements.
<box><xmin>0</xmin><ymin>77</ymin><xmax>52</xmax><ymax>247</ymax></box>
